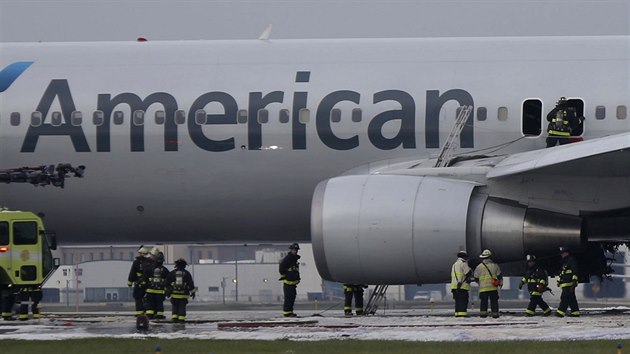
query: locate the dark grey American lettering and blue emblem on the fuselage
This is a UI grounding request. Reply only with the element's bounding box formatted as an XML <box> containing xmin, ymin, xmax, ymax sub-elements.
<box><xmin>9</xmin><ymin>67</ymin><xmax>474</xmax><ymax>153</ymax></box>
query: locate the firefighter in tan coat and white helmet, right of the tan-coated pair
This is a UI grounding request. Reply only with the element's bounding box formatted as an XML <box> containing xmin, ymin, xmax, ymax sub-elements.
<box><xmin>473</xmin><ymin>250</ymin><xmax>503</xmax><ymax>318</ymax></box>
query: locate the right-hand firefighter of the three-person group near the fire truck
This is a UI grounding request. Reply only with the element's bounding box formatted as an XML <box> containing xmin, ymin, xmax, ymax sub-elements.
<box><xmin>166</xmin><ymin>258</ymin><xmax>195</xmax><ymax>322</ymax></box>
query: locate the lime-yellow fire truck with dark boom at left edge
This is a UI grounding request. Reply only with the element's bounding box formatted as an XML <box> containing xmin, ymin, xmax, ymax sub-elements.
<box><xmin>0</xmin><ymin>164</ymin><xmax>85</xmax><ymax>316</ymax></box>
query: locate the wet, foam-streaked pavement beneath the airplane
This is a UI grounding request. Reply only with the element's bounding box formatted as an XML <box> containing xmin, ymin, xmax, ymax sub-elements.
<box><xmin>0</xmin><ymin>307</ymin><xmax>630</xmax><ymax>341</ymax></box>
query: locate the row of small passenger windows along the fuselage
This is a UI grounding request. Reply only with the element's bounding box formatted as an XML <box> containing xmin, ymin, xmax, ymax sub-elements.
<box><xmin>2</xmin><ymin>105</ymin><xmax>628</xmax><ymax>127</ymax></box>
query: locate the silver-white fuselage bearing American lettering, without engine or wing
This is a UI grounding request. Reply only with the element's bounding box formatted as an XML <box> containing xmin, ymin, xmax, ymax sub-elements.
<box><xmin>0</xmin><ymin>36</ymin><xmax>630</xmax><ymax>243</ymax></box>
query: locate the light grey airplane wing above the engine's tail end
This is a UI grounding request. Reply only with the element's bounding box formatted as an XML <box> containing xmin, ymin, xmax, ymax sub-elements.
<box><xmin>486</xmin><ymin>133</ymin><xmax>630</xmax><ymax>179</ymax></box>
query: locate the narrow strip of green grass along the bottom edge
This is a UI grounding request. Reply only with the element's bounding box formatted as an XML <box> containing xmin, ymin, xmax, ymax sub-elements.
<box><xmin>0</xmin><ymin>338</ymin><xmax>630</xmax><ymax>354</ymax></box>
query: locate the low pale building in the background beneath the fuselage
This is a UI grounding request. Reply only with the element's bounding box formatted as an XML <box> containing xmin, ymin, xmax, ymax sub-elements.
<box><xmin>44</xmin><ymin>244</ymin><xmax>323</xmax><ymax>306</ymax></box>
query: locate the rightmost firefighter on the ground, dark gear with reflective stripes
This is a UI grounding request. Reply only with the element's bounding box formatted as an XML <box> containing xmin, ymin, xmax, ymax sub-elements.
<box><xmin>556</xmin><ymin>247</ymin><xmax>580</xmax><ymax>317</ymax></box>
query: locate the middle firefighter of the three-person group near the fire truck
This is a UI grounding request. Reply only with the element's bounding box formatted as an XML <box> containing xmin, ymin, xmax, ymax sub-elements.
<box><xmin>144</xmin><ymin>252</ymin><xmax>169</xmax><ymax>320</ymax></box>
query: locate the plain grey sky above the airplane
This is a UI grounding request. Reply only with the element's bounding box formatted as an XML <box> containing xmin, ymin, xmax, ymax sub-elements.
<box><xmin>0</xmin><ymin>0</ymin><xmax>630</xmax><ymax>42</ymax></box>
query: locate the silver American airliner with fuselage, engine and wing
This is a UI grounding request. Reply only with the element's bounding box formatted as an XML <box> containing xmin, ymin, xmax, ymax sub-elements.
<box><xmin>0</xmin><ymin>36</ymin><xmax>630</xmax><ymax>284</ymax></box>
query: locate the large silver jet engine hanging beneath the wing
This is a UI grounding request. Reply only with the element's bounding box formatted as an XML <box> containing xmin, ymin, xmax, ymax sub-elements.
<box><xmin>311</xmin><ymin>175</ymin><xmax>582</xmax><ymax>284</ymax></box>
